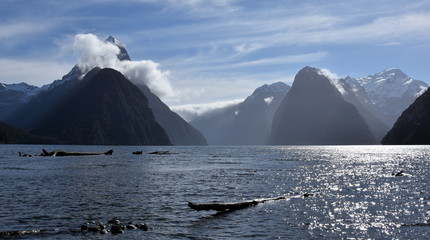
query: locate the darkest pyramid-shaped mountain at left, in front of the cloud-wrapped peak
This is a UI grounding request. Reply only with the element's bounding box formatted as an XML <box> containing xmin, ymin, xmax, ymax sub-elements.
<box><xmin>32</xmin><ymin>68</ymin><xmax>170</xmax><ymax>145</ymax></box>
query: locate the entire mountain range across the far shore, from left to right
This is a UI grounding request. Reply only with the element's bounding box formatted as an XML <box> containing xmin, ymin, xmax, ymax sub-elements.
<box><xmin>0</xmin><ymin>34</ymin><xmax>428</xmax><ymax>145</ymax></box>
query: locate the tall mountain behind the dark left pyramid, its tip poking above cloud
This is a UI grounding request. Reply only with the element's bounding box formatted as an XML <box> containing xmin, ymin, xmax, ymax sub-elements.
<box><xmin>6</xmin><ymin>36</ymin><xmax>207</xmax><ymax>145</ymax></box>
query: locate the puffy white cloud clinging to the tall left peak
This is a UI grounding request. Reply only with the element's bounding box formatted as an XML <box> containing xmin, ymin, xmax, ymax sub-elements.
<box><xmin>73</xmin><ymin>34</ymin><xmax>174</xmax><ymax>97</ymax></box>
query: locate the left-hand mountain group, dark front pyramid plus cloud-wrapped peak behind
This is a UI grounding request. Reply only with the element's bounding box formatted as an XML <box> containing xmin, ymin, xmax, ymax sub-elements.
<box><xmin>0</xmin><ymin>37</ymin><xmax>207</xmax><ymax>145</ymax></box>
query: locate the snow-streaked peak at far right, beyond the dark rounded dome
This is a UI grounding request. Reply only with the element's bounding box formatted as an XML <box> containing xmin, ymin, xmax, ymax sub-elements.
<box><xmin>348</xmin><ymin>68</ymin><xmax>428</xmax><ymax>128</ymax></box>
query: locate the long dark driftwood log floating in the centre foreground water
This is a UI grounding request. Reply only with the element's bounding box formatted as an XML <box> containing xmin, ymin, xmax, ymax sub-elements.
<box><xmin>188</xmin><ymin>193</ymin><xmax>313</xmax><ymax>212</ymax></box>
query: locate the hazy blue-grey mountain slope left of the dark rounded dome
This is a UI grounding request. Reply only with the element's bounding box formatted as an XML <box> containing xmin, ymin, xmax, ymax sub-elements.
<box><xmin>190</xmin><ymin>82</ymin><xmax>290</xmax><ymax>145</ymax></box>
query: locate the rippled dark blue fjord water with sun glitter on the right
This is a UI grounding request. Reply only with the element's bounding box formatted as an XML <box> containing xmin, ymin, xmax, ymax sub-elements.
<box><xmin>0</xmin><ymin>145</ymin><xmax>430</xmax><ymax>239</ymax></box>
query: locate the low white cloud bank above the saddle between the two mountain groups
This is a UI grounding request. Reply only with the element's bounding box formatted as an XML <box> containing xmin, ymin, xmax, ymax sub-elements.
<box><xmin>171</xmin><ymin>99</ymin><xmax>244</xmax><ymax>121</ymax></box>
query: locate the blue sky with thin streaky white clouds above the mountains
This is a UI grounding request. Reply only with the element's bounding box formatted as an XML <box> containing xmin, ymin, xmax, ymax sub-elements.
<box><xmin>0</xmin><ymin>0</ymin><xmax>430</xmax><ymax>114</ymax></box>
